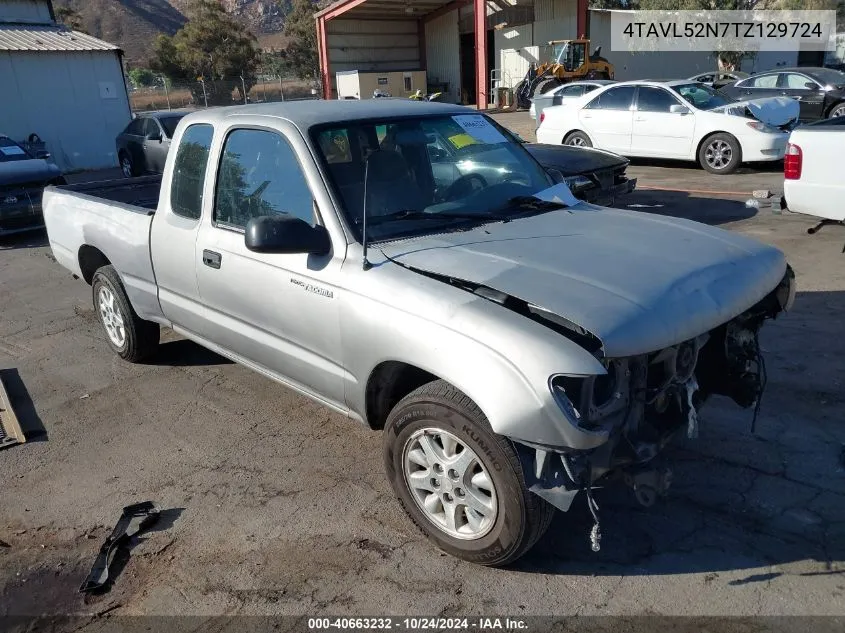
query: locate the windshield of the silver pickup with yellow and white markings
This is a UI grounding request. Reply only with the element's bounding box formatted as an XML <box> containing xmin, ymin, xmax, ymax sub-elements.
<box><xmin>311</xmin><ymin>114</ymin><xmax>552</xmax><ymax>241</ymax></box>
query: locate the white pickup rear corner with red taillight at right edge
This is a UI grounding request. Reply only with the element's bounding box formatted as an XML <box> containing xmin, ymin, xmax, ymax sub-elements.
<box><xmin>780</xmin><ymin>117</ymin><xmax>845</xmax><ymax>228</ymax></box>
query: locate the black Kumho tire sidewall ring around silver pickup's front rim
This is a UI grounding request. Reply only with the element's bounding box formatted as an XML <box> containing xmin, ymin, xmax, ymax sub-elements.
<box><xmin>384</xmin><ymin>399</ymin><xmax>526</xmax><ymax>565</ymax></box>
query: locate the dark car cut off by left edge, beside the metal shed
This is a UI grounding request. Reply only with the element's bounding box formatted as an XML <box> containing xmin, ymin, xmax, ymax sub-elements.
<box><xmin>0</xmin><ymin>135</ymin><xmax>65</xmax><ymax>235</ymax></box>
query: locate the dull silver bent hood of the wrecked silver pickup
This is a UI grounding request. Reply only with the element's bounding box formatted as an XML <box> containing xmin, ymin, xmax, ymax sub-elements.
<box><xmin>378</xmin><ymin>205</ymin><xmax>786</xmax><ymax>357</ymax></box>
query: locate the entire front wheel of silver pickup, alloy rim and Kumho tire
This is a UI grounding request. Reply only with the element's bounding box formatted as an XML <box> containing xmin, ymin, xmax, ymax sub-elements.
<box><xmin>384</xmin><ymin>380</ymin><xmax>554</xmax><ymax>566</ymax></box>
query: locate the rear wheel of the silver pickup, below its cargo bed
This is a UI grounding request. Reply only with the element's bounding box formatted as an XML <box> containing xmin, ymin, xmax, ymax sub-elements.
<box><xmin>91</xmin><ymin>266</ymin><xmax>161</xmax><ymax>363</ymax></box>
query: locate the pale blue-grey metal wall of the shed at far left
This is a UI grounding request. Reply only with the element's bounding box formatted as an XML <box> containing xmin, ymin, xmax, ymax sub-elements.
<box><xmin>0</xmin><ymin>51</ymin><xmax>130</xmax><ymax>171</ymax></box>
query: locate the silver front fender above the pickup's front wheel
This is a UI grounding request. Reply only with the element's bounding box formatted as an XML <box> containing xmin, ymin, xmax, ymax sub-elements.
<box><xmin>341</xmin><ymin>264</ymin><xmax>607</xmax><ymax>449</ymax></box>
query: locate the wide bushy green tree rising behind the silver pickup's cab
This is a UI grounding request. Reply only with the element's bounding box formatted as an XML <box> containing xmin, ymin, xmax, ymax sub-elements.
<box><xmin>151</xmin><ymin>0</ymin><xmax>260</xmax><ymax>105</ymax></box>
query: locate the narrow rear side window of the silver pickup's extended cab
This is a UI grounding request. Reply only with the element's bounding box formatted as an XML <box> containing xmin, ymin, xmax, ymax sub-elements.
<box><xmin>170</xmin><ymin>123</ymin><xmax>214</xmax><ymax>220</ymax></box>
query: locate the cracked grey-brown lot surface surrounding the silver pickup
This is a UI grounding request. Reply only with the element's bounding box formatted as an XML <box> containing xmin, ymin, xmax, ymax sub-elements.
<box><xmin>0</xmin><ymin>114</ymin><xmax>845</xmax><ymax>616</ymax></box>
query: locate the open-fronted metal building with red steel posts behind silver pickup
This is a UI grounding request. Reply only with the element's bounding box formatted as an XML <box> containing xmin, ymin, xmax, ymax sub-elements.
<box><xmin>316</xmin><ymin>0</ymin><xmax>588</xmax><ymax>108</ymax></box>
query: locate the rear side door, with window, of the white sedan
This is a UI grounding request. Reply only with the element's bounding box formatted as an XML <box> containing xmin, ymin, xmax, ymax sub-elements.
<box><xmin>578</xmin><ymin>86</ymin><xmax>636</xmax><ymax>154</ymax></box>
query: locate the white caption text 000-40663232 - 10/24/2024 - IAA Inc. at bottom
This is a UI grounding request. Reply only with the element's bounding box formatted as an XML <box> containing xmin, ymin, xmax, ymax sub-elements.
<box><xmin>308</xmin><ymin>616</ymin><xmax>528</xmax><ymax>633</ymax></box>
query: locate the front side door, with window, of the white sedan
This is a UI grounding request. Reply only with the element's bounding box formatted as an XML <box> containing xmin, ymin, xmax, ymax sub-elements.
<box><xmin>631</xmin><ymin>86</ymin><xmax>695</xmax><ymax>158</ymax></box>
